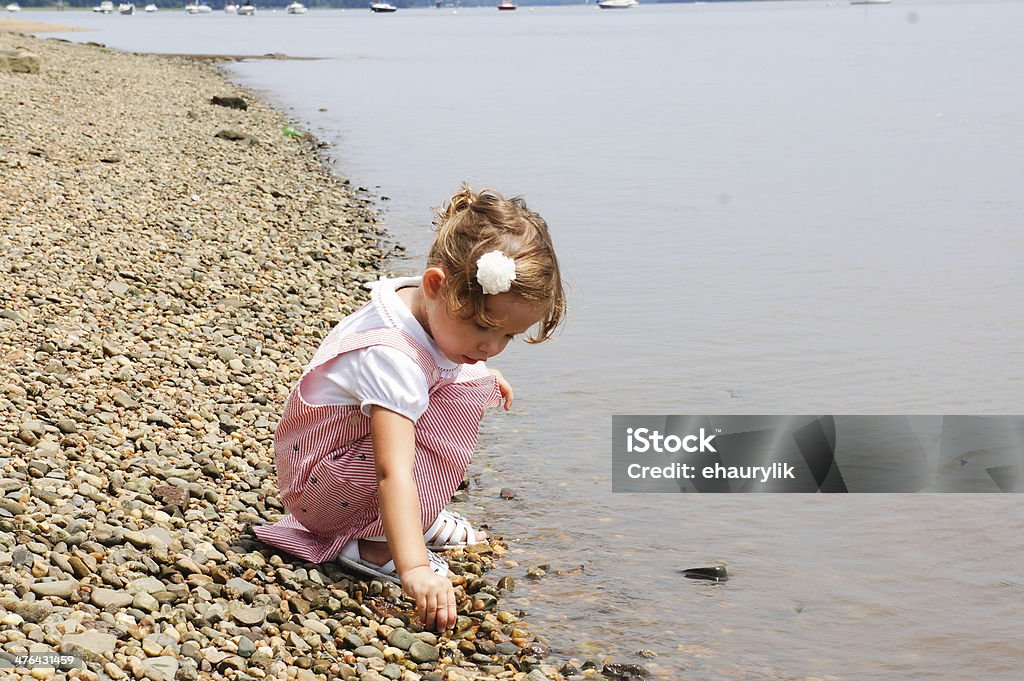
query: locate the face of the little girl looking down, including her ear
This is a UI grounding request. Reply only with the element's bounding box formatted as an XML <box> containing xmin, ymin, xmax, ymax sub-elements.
<box><xmin>423</xmin><ymin>270</ymin><xmax>545</xmax><ymax>365</ymax></box>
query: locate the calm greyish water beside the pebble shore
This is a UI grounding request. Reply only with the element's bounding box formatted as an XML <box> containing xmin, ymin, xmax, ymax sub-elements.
<box><xmin>36</xmin><ymin>0</ymin><xmax>1024</xmax><ymax>680</ymax></box>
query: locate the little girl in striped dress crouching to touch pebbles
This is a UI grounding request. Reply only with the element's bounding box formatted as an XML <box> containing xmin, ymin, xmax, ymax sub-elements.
<box><xmin>256</xmin><ymin>185</ymin><xmax>565</xmax><ymax>631</ymax></box>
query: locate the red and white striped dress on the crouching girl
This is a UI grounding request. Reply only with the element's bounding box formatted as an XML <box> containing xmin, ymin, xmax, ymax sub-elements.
<box><xmin>255</xmin><ymin>294</ymin><xmax>501</xmax><ymax>563</ymax></box>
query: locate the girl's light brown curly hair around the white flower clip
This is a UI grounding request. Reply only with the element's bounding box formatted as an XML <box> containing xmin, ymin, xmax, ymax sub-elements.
<box><xmin>427</xmin><ymin>183</ymin><xmax>565</xmax><ymax>343</ymax></box>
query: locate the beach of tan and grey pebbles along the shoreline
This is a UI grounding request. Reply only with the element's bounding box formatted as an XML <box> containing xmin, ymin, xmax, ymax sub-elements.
<box><xmin>0</xmin><ymin>20</ymin><xmax>622</xmax><ymax>681</ymax></box>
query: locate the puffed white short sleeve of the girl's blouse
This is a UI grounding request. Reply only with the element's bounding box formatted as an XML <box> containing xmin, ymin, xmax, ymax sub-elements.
<box><xmin>302</xmin><ymin>346</ymin><xmax>430</xmax><ymax>421</ymax></box>
